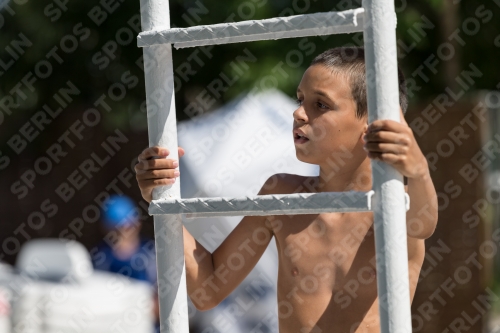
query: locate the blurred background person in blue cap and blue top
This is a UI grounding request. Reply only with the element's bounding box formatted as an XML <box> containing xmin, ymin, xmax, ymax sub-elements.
<box><xmin>92</xmin><ymin>195</ymin><xmax>159</xmax><ymax>332</ymax></box>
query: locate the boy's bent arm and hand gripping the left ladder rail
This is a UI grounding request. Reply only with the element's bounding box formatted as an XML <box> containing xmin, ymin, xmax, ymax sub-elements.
<box><xmin>135</xmin><ymin>147</ymin><xmax>273</xmax><ymax>310</ymax></box>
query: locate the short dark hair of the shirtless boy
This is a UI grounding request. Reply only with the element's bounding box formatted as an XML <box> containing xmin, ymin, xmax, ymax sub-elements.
<box><xmin>311</xmin><ymin>47</ymin><xmax>408</xmax><ymax>118</ymax></box>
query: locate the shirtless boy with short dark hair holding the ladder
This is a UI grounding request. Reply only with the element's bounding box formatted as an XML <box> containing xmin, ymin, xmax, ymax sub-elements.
<box><xmin>136</xmin><ymin>48</ymin><xmax>437</xmax><ymax>333</ymax></box>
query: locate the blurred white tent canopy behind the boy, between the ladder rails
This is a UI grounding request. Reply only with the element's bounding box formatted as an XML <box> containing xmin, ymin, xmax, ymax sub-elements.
<box><xmin>178</xmin><ymin>90</ymin><xmax>319</xmax><ymax>244</ymax></box>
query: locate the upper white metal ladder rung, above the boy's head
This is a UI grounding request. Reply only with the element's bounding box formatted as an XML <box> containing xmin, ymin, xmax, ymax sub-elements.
<box><xmin>137</xmin><ymin>8</ymin><xmax>364</xmax><ymax>48</ymax></box>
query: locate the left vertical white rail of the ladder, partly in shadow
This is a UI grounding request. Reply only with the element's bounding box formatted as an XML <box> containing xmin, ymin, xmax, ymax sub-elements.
<box><xmin>141</xmin><ymin>0</ymin><xmax>189</xmax><ymax>333</ymax></box>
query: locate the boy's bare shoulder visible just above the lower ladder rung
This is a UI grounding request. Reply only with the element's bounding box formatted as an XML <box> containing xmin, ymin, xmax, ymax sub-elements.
<box><xmin>259</xmin><ymin>173</ymin><xmax>318</xmax><ymax>195</ymax></box>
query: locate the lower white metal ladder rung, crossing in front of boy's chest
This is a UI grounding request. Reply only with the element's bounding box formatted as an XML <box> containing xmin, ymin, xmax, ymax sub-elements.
<box><xmin>149</xmin><ymin>191</ymin><xmax>373</xmax><ymax>217</ymax></box>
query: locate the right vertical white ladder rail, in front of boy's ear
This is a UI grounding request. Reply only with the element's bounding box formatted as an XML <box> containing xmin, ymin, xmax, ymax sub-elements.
<box><xmin>363</xmin><ymin>0</ymin><xmax>412</xmax><ymax>333</ymax></box>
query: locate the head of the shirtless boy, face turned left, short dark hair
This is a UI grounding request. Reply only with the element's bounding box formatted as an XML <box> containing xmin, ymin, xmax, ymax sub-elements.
<box><xmin>293</xmin><ymin>47</ymin><xmax>408</xmax><ymax>169</ymax></box>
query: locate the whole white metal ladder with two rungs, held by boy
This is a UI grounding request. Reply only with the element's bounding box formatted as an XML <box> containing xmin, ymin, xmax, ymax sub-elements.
<box><xmin>138</xmin><ymin>0</ymin><xmax>411</xmax><ymax>333</ymax></box>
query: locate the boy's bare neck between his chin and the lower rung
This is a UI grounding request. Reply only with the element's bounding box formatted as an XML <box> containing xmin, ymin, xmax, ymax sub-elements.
<box><xmin>316</xmin><ymin>158</ymin><xmax>372</xmax><ymax>192</ymax></box>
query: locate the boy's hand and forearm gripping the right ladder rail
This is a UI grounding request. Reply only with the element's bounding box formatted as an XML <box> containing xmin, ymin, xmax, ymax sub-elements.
<box><xmin>363</xmin><ymin>111</ymin><xmax>438</xmax><ymax>239</ymax></box>
